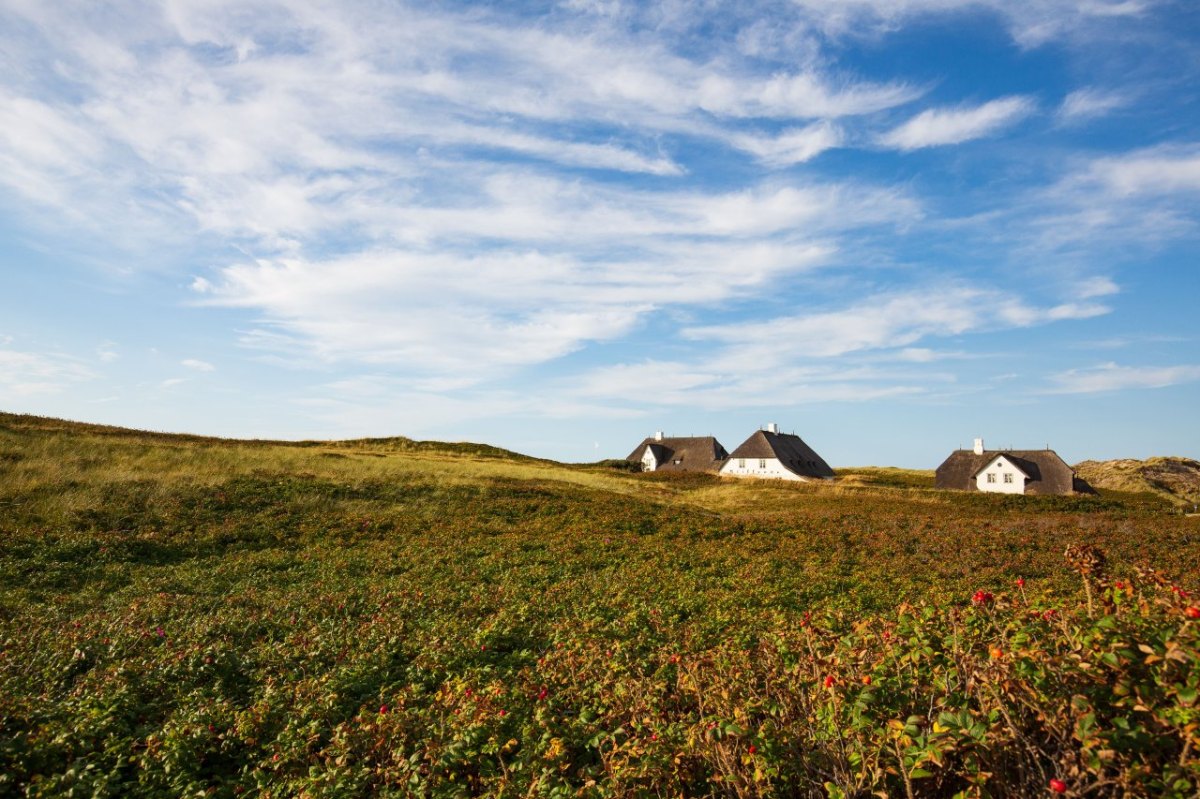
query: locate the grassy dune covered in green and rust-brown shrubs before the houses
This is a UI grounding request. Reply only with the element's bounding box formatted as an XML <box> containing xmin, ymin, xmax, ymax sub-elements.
<box><xmin>0</xmin><ymin>415</ymin><xmax>1200</xmax><ymax>797</ymax></box>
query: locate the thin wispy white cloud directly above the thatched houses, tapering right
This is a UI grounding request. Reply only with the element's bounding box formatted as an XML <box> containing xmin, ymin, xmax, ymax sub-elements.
<box><xmin>552</xmin><ymin>279</ymin><xmax>1110</xmax><ymax>410</ymax></box>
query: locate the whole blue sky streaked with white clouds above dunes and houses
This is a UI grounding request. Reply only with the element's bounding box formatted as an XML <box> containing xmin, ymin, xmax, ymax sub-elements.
<box><xmin>0</xmin><ymin>0</ymin><xmax>1200</xmax><ymax>468</ymax></box>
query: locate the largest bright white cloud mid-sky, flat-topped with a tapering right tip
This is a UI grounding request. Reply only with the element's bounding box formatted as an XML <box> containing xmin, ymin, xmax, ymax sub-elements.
<box><xmin>197</xmin><ymin>235</ymin><xmax>844</xmax><ymax>379</ymax></box>
